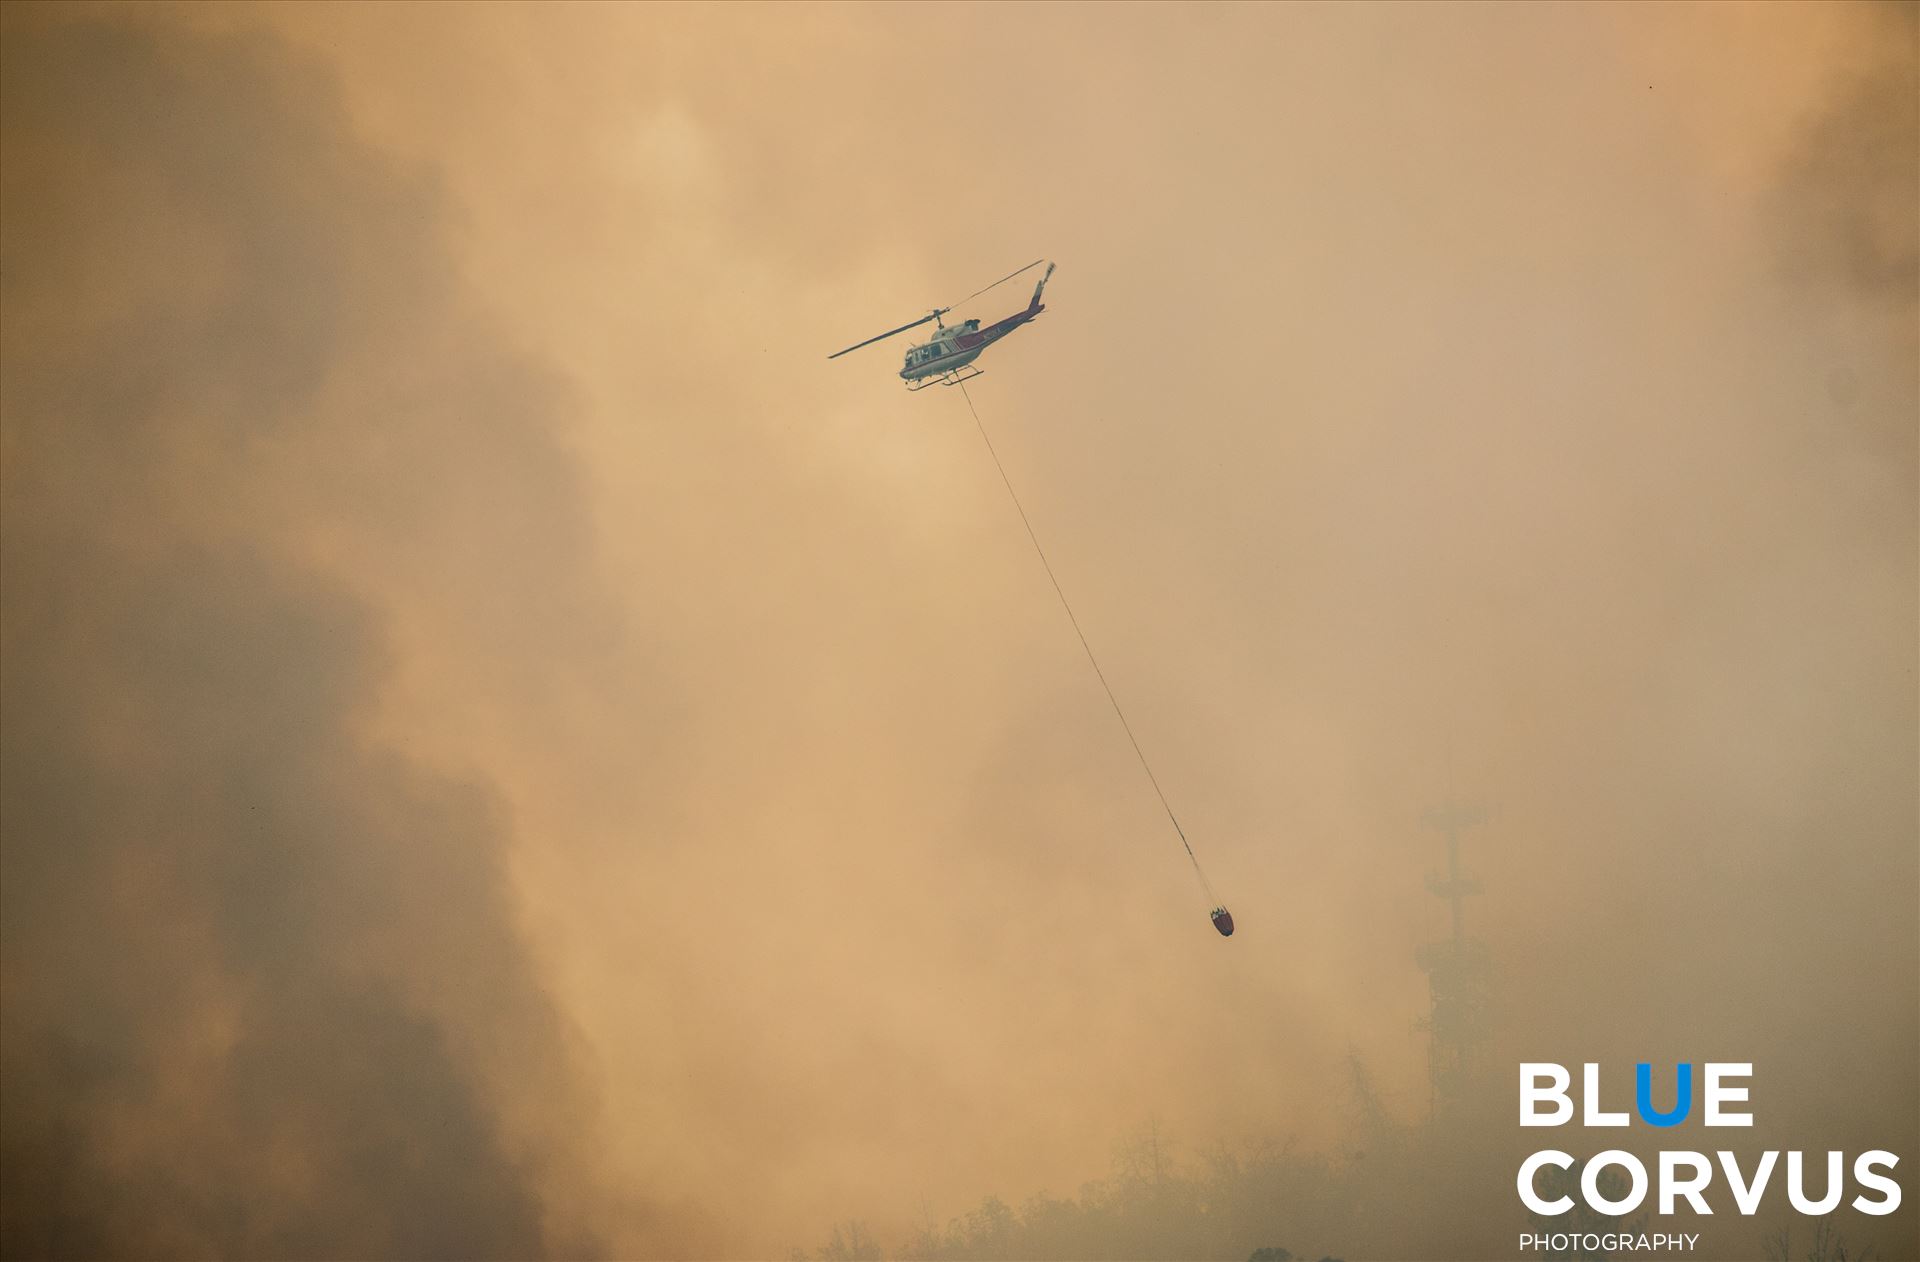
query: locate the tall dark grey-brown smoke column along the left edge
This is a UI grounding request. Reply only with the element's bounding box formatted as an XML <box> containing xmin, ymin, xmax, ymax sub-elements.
<box><xmin>0</xmin><ymin>8</ymin><xmax>622</xmax><ymax>1258</ymax></box>
